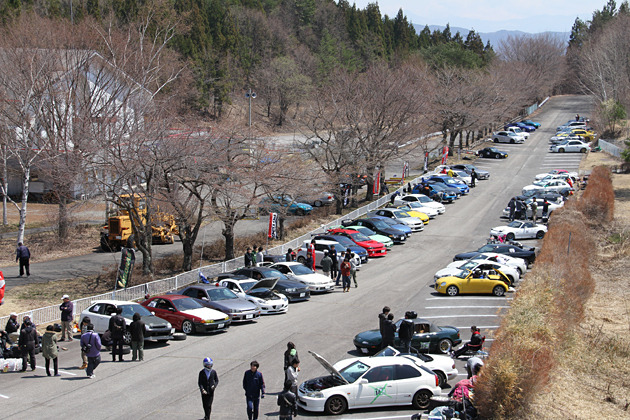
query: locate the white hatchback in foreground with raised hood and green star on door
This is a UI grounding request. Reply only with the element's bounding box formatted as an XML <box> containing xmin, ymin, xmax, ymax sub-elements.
<box><xmin>297</xmin><ymin>351</ymin><xmax>442</xmax><ymax>415</ymax></box>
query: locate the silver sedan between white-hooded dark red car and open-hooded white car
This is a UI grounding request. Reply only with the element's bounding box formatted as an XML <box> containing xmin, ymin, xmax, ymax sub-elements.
<box><xmin>176</xmin><ymin>284</ymin><xmax>260</xmax><ymax>322</ymax></box>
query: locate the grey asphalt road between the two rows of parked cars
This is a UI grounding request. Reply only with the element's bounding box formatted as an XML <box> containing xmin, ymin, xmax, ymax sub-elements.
<box><xmin>0</xmin><ymin>96</ymin><xmax>591</xmax><ymax>420</ymax></box>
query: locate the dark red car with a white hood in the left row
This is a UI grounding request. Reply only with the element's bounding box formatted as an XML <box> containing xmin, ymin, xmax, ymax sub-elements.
<box><xmin>141</xmin><ymin>295</ymin><xmax>232</xmax><ymax>334</ymax></box>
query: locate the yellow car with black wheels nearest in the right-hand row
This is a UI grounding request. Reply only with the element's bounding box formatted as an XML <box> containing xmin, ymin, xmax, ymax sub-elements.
<box><xmin>435</xmin><ymin>270</ymin><xmax>510</xmax><ymax>296</ymax></box>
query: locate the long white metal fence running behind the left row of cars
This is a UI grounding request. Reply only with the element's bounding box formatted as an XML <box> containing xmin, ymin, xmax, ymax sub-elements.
<box><xmin>0</xmin><ymin>177</ymin><xmax>420</xmax><ymax>328</ymax></box>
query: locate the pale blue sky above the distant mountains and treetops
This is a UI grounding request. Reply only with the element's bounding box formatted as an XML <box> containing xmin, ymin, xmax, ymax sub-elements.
<box><xmin>348</xmin><ymin>0</ymin><xmax>608</xmax><ymax>33</ymax></box>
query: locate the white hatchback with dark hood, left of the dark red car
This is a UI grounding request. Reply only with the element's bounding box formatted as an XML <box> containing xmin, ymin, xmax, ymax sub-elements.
<box><xmin>79</xmin><ymin>300</ymin><xmax>177</xmax><ymax>344</ymax></box>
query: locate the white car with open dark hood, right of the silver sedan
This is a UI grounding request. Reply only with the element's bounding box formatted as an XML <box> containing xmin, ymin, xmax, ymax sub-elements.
<box><xmin>219</xmin><ymin>276</ymin><xmax>289</xmax><ymax>315</ymax></box>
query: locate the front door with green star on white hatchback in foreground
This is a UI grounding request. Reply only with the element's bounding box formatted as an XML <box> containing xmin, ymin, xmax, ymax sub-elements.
<box><xmin>355</xmin><ymin>365</ymin><xmax>398</xmax><ymax>407</ymax></box>
